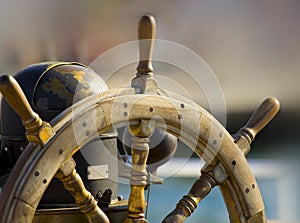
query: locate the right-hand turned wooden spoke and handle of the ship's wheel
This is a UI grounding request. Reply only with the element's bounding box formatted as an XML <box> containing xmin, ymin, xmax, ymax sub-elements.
<box><xmin>163</xmin><ymin>98</ymin><xmax>280</xmax><ymax>223</ymax></box>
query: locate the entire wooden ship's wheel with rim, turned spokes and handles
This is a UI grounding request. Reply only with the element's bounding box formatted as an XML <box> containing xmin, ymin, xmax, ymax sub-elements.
<box><xmin>0</xmin><ymin>16</ymin><xmax>279</xmax><ymax>223</ymax></box>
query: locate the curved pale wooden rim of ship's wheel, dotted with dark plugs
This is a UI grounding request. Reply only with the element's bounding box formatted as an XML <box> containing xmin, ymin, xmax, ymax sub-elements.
<box><xmin>0</xmin><ymin>90</ymin><xmax>265</xmax><ymax>222</ymax></box>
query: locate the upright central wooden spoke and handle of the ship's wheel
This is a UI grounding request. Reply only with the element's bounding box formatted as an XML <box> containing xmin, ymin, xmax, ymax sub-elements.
<box><xmin>124</xmin><ymin>15</ymin><xmax>157</xmax><ymax>223</ymax></box>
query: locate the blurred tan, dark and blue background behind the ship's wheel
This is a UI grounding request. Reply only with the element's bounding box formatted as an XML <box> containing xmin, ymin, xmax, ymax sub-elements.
<box><xmin>0</xmin><ymin>0</ymin><xmax>300</xmax><ymax>222</ymax></box>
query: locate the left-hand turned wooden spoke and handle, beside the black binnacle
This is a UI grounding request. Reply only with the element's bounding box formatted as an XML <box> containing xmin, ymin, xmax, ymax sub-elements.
<box><xmin>0</xmin><ymin>75</ymin><xmax>109</xmax><ymax>223</ymax></box>
